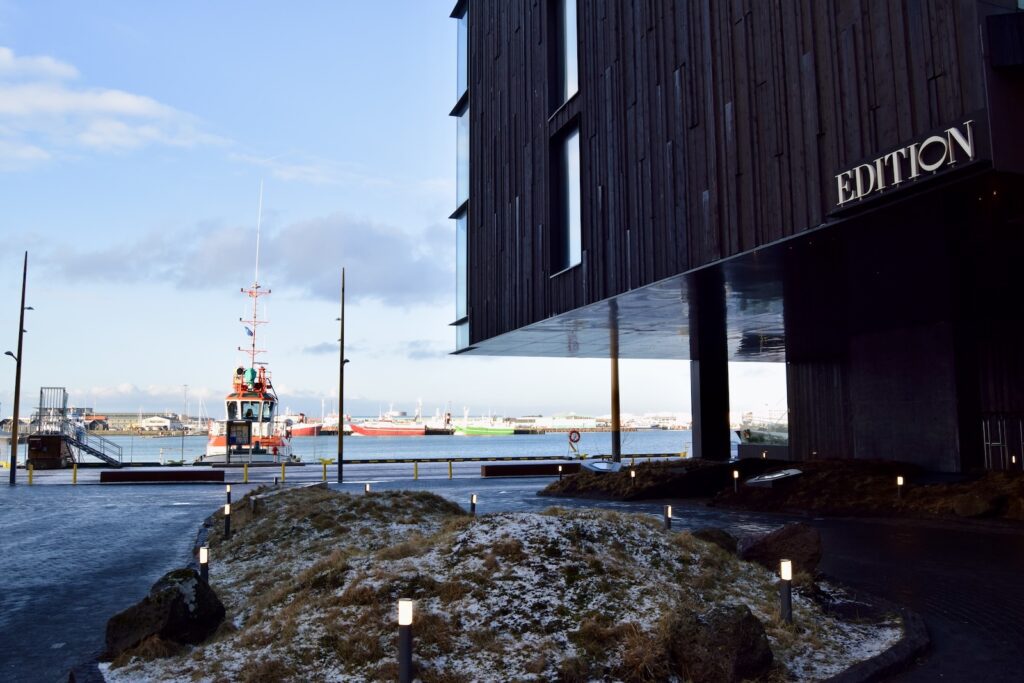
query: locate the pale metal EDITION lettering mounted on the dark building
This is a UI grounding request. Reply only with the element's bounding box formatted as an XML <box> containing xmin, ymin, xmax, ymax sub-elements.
<box><xmin>836</xmin><ymin>121</ymin><xmax>975</xmax><ymax>206</ymax></box>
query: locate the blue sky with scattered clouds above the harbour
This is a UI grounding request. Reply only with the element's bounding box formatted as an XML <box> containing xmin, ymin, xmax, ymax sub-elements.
<box><xmin>0</xmin><ymin>0</ymin><xmax>785</xmax><ymax>417</ymax></box>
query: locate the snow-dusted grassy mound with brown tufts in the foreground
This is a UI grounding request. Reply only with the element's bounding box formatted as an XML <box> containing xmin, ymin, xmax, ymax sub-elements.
<box><xmin>105</xmin><ymin>488</ymin><xmax>900</xmax><ymax>683</ymax></box>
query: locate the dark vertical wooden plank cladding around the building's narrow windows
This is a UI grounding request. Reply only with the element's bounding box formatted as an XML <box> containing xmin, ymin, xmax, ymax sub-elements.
<box><xmin>468</xmin><ymin>0</ymin><xmax>985</xmax><ymax>342</ymax></box>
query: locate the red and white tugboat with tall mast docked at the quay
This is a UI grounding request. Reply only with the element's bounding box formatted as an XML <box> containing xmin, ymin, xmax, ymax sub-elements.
<box><xmin>195</xmin><ymin>185</ymin><xmax>302</xmax><ymax>465</ymax></box>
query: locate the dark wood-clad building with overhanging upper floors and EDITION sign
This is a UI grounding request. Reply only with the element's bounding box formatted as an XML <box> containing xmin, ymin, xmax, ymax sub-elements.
<box><xmin>452</xmin><ymin>0</ymin><xmax>1024</xmax><ymax>471</ymax></box>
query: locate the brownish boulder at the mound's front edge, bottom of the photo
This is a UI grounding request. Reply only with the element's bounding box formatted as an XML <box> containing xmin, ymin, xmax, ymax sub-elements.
<box><xmin>669</xmin><ymin>605</ymin><xmax>774</xmax><ymax>683</ymax></box>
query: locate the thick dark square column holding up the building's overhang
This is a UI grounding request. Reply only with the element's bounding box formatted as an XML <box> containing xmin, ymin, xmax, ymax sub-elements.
<box><xmin>689</xmin><ymin>273</ymin><xmax>731</xmax><ymax>461</ymax></box>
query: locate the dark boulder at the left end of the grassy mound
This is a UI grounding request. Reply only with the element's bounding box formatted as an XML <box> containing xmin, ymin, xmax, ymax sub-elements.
<box><xmin>102</xmin><ymin>569</ymin><xmax>224</xmax><ymax>659</ymax></box>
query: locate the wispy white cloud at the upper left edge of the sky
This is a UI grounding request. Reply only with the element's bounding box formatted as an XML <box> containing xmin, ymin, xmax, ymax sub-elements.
<box><xmin>0</xmin><ymin>47</ymin><xmax>226</xmax><ymax>163</ymax></box>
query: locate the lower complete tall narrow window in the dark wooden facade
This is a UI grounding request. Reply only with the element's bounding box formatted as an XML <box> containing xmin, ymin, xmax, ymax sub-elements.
<box><xmin>551</xmin><ymin>128</ymin><xmax>583</xmax><ymax>272</ymax></box>
